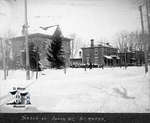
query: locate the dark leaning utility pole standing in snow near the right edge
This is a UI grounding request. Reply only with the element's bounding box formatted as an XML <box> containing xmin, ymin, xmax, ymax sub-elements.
<box><xmin>139</xmin><ymin>5</ymin><xmax>148</xmax><ymax>73</ymax></box>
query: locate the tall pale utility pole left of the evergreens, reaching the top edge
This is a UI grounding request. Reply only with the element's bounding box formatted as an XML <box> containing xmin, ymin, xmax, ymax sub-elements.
<box><xmin>24</xmin><ymin>0</ymin><xmax>30</xmax><ymax>80</ymax></box>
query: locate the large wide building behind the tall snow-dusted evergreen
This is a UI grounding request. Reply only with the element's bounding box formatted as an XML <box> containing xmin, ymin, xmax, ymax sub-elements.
<box><xmin>10</xmin><ymin>31</ymin><xmax>71</xmax><ymax>66</ymax></box>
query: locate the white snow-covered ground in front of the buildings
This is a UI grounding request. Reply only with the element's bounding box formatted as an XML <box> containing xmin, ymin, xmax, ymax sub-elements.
<box><xmin>0</xmin><ymin>67</ymin><xmax>150</xmax><ymax>113</ymax></box>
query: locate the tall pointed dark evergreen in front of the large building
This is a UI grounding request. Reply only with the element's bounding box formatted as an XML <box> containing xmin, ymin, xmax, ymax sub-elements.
<box><xmin>47</xmin><ymin>28</ymin><xmax>65</xmax><ymax>69</ymax></box>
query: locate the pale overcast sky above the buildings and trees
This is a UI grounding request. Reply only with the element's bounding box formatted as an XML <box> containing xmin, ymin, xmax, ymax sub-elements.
<box><xmin>0</xmin><ymin>0</ymin><xmax>143</xmax><ymax>43</ymax></box>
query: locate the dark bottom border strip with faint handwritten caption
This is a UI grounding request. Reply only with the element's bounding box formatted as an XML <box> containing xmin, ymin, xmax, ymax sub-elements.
<box><xmin>0</xmin><ymin>113</ymin><xmax>150</xmax><ymax>123</ymax></box>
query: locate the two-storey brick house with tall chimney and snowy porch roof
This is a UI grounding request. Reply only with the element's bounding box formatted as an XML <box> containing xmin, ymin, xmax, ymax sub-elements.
<box><xmin>82</xmin><ymin>39</ymin><xmax>120</xmax><ymax>66</ymax></box>
